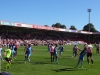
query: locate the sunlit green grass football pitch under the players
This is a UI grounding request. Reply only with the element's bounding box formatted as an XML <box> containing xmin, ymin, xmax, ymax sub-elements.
<box><xmin>1</xmin><ymin>45</ymin><xmax>100</xmax><ymax>75</ymax></box>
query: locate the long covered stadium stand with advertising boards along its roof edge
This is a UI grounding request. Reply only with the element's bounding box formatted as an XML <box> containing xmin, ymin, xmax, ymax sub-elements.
<box><xmin>0</xmin><ymin>21</ymin><xmax>100</xmax><ymax>45</ymax></box>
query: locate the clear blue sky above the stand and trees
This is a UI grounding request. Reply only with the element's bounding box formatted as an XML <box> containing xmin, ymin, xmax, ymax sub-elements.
<box><xmin>0</xmin><ymin>0</ymin><xmax>100</xmax><ymax>31</ymax></box>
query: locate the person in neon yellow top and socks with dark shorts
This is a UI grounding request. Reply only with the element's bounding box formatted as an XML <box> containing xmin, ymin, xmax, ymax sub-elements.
<box><xmin>4</xmin><ymin>46</ymin><xmax>12</xmax><ymax>69</ymax></box>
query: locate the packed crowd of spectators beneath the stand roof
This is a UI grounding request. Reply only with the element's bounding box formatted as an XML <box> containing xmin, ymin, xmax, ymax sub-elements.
<box><xmin>0</xmin><ymin>32</ymin><xmax>84</xmax><ymax>45</ymax></box>
